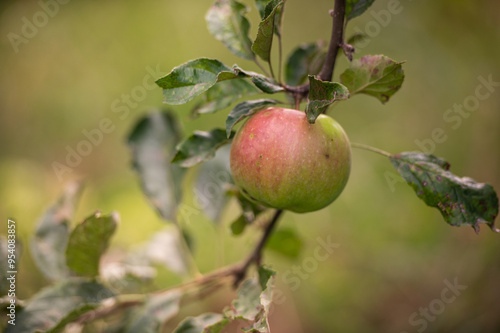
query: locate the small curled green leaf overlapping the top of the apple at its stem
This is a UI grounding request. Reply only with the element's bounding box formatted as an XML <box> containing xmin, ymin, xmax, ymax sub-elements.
<box><xmin>306</xmin><ymin>75</ymin><xmax>349</xmax><ymax>124</ymax></box>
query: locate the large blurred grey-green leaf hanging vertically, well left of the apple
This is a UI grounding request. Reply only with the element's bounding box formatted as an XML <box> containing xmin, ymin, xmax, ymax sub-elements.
<box><xmin>128</xmin><ymin>111</ymin><xmax>185</xmax><ymax>221</ymax></box>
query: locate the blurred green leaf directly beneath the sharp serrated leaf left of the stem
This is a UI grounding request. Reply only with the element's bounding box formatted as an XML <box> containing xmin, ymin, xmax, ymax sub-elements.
<box><xmin>193</xmin><ymin>79</ymin><xmax>261</xmax><ymax>116</ymax></box>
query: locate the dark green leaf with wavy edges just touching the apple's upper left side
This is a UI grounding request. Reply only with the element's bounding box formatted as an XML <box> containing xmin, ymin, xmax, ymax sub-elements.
<box><xmin>172</xmin><ymin>128</ymin><xmax>231</xmax><ymax>168</ymax></box>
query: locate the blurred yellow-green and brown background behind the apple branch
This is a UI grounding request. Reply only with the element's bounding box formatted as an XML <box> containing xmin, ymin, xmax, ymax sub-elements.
<box><xmin>0</xmin><ymin>0</ymin><xmax>500</xmax><ymax>333</ymax></box>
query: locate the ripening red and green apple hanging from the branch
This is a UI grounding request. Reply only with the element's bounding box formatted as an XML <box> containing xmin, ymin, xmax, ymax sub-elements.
<box><xmin>230</xmin><ymin>107</ymin><xmax>351</xmax><ymax>213</ymax></box>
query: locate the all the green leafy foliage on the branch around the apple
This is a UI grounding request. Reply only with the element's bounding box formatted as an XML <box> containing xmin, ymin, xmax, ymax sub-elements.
<box><xmin>6</xmin><ymin>0</ymin><xmax>498</xmax><ymax>333</ymax></box>
